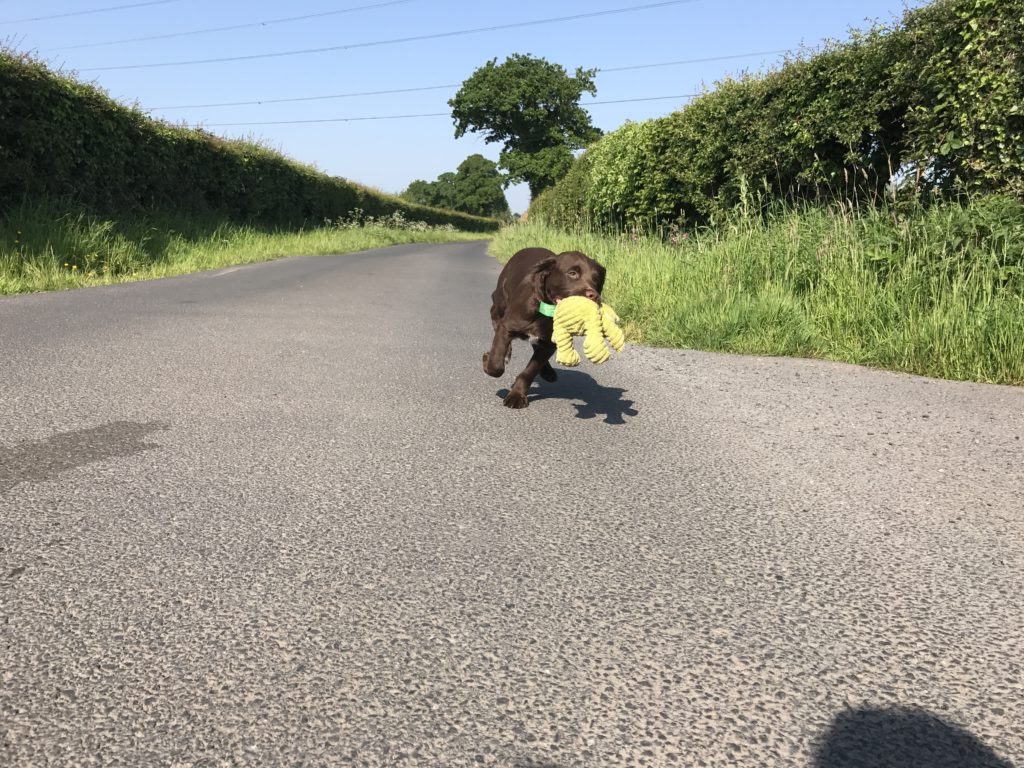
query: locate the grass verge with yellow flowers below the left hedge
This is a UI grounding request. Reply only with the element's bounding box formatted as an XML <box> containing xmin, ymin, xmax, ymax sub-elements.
<box><xmin>0</xmin><ymin>203</ymin><xmax>485</xmax><ymax>295</ymax></box>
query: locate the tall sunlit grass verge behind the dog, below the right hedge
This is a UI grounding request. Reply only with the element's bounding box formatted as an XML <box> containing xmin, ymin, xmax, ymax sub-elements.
<box><xmin>492</xmin><ymin>198</ymin><xmax>1024</xmax><ymax>385</ymax></box>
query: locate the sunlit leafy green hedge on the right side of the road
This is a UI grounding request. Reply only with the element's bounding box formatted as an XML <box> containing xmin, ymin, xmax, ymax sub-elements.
<box><xmin>530</xmin><ymin>0</ymin><xmax>1024</xmax><ymax>225</ymax></box>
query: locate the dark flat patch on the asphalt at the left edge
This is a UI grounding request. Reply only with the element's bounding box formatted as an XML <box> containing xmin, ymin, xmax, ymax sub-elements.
<box><xmin>0</xmin><ymin>421</ymin><xmax>167</xmax><ymax>494</ymax></box>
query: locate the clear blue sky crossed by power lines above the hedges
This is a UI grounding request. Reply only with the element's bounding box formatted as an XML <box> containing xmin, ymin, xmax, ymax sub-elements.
<box><xmin>0</xmin><ymin>0</ymin><xmax>922</xmax><ymax>211</ymax></box>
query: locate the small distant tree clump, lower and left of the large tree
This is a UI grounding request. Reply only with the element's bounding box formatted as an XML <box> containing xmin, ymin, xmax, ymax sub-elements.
<box><xmin>401</xmin><ymin>155</ymin><xmax>509</xmax><ymax>218</ymax></box>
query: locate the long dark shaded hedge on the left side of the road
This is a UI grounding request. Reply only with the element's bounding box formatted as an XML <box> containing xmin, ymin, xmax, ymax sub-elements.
<box><xmin>0</xmin><ymin>50</ymin><xmax>499</xmax><ymax>231</ymax></box>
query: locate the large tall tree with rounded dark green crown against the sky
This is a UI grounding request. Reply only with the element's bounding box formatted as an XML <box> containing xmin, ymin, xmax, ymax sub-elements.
<box><xmin>449</xmin><ymin>53</ymin><xmax>601</xmax><ymax>197</ymax></box>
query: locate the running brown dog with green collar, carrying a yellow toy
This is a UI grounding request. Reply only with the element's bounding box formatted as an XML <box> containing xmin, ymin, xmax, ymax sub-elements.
<box><xmin>483</xmin><ymin>248</ymin><xmax>605</xmax><ymax>408</ymax></box>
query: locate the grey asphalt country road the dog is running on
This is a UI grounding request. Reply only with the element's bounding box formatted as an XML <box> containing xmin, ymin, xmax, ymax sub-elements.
<box><xmin>0</xmin><ymin>244</ymin><xmax>1024</xmax><ymax>768</ymax></box>
